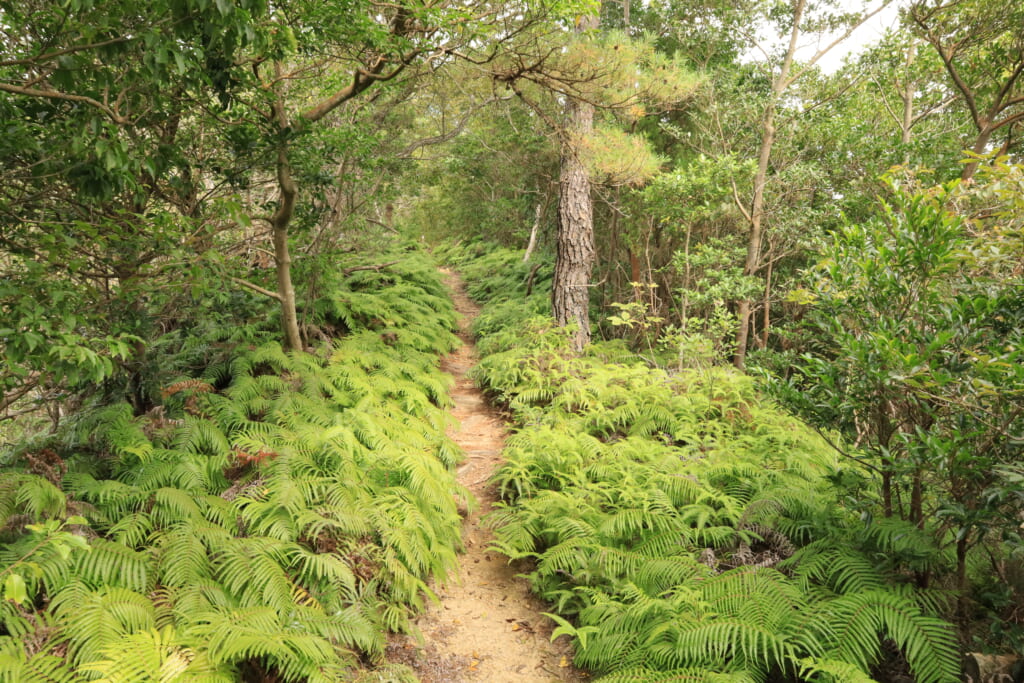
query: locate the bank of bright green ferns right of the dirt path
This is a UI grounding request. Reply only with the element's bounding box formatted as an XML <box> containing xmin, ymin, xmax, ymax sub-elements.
<box><xmin>446</xmin><ymin>242</ymin><xmax>959</xmax><ymax>683</ymax></box>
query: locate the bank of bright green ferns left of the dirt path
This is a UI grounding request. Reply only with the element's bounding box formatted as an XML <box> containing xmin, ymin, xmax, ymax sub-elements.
<box><xmin>0</xmin><ymin>254</ymin><xmax>469</xmax><ymax>683</ymax></box>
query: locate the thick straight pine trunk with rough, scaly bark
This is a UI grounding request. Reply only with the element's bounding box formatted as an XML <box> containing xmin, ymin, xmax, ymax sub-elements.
<box><xmin>551</xmin><ymin>16</ymin><xmax>598</xmax><ymax>352</ymax></box>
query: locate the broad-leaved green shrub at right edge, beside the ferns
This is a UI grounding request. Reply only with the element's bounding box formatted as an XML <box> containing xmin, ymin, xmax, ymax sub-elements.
<box><xmin>781</xmin><ymin>163</ymin><xmax>1024</xmax><ymax>634</ymax></box>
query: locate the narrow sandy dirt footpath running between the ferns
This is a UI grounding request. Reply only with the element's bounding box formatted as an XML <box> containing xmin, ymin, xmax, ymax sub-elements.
<box><xmin>388</xmin><ymin>270</ymin><xmax>586</xmax><ymax>683</ymax></box>
